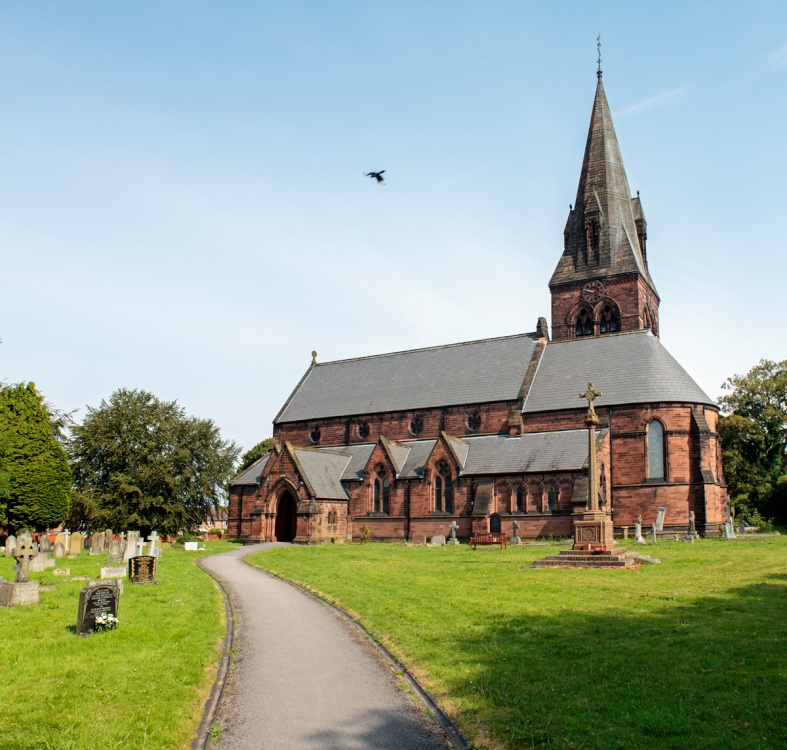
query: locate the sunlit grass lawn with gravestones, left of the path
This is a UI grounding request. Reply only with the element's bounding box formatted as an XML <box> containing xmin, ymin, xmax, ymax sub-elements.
<box><xmin>0</xmin><ymin>541</ymin><xmax>243</xmax><ymax>750</ymax></box>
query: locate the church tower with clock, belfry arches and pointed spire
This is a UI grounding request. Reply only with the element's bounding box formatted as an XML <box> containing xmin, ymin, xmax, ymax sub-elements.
<box><xmin>549</xmin><ymin>70</ymin><xmax>659</xmax><ymax>341</ymax></box>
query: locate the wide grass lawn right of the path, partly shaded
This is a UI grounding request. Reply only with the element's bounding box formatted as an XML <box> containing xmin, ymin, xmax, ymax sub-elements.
<box><xmin>247</xmin><ymin>536</ymin><xmax>787</xmax><ymax>750</ymax></box>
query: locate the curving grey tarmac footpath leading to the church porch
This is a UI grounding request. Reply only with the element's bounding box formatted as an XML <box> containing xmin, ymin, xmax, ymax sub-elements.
<box><xmin>201</xmin><ymin>544</ymin><xmax>452</xmax><ymax>750</ymax></box>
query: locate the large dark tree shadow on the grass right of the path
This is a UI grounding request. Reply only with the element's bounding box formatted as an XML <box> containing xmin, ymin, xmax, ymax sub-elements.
<box><xmin>446</xmin><ymin>575</ymin><xmax>787</xmax><ymax>750</ymax></box>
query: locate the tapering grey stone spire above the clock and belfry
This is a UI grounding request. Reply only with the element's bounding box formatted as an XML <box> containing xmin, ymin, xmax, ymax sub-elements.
<box><xmin>549</xmin><ymin>76</ymin><xmax>658</xmax><ymax>299</ymax></box>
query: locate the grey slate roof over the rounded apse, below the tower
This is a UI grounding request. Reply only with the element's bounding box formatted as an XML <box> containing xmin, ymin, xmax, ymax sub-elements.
<box><xmin>523</xmin><ymin>331</ymin><xmax>713</xmax><ymax>414</ymax></box>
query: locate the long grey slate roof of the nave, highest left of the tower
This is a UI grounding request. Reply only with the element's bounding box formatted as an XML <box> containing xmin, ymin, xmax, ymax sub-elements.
<box><xmin>274</xmin><ymin>333</ymin><xmax>537</xmax><ymax>424</ymax></box>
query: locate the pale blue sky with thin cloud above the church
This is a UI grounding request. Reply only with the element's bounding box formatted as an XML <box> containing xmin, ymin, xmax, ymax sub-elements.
<box><xmin>0</xmin><ymin>0</ymin><xmax>787</xmax><ymax>448</ymax></box>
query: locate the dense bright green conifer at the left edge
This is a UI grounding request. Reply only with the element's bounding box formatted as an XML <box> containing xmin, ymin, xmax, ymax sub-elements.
<box><xmin>0</xmin><ymin>383</ymin><xmax>71</xmax><ymax>530</ymax></box>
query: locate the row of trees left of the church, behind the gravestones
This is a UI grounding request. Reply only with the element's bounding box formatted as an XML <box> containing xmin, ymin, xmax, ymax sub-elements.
<box><xmin>0</xmin><ymin>383</ymin><xmax>265</xmax><ymax>535</ymax></box>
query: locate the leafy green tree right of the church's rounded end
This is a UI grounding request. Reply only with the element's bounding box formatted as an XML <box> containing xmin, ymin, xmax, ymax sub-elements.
<box><xmin>719</xmin><ymin>359</ymin><xmax>787</xmax><ymax>522</ymax></box>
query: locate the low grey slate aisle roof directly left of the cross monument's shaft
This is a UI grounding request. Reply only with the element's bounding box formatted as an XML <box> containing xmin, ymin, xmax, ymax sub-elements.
<box><xmin>462</xmin><ymin>430</ymin><xmax>592</xmax><ymax>476</ymax></box>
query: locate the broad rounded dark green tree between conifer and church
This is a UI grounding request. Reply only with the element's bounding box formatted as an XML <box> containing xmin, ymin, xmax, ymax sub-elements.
<box><xmin>70</xmin><ymin>389</ymin><xmax>240</xmax><ymax>534</ymax></box>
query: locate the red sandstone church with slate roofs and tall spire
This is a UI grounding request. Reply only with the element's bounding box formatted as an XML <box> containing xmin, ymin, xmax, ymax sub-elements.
<box><xmin>228</xmin><ymin>71</ymin><xmax>727</xmax><ymax>543</ymax></box>
